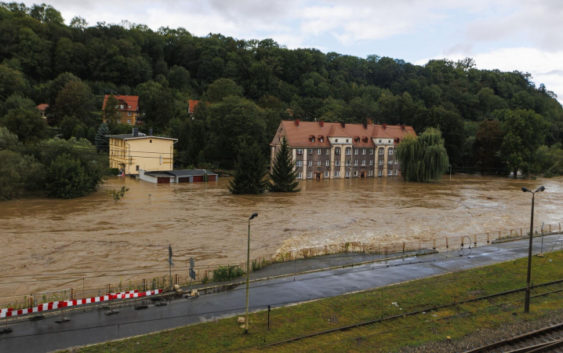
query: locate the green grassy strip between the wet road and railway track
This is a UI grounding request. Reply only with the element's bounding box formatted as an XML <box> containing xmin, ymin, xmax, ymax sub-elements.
<box><xmin>64</xmin><ymin>252</ymin><xmax>563</xmax><ymax>352</ymax></box>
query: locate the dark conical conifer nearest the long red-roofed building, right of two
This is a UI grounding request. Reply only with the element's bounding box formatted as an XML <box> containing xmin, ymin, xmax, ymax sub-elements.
<box><xmin>270</xmin><ymin>137</ymin><xmax>299</xmax><ymax>192</ymax></box>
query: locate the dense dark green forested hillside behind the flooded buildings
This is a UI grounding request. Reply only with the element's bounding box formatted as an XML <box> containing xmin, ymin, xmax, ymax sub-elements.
<box><xmin>0</xmin><ymin>3</ymin><xmax>563</xmax><ymax>187</ymax></box>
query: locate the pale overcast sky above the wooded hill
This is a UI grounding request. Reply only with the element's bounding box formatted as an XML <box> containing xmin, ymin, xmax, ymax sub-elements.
<box><xmin>24</xmin><ymin>0</ymin><xmax>563</xmax><ymax>102</ymax></box>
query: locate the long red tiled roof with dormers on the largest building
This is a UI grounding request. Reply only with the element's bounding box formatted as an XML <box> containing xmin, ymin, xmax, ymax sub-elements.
<box><xmin>272</xmin><ymin>120</ymin><xmax>416</xmax><ymax>148</ymax></box>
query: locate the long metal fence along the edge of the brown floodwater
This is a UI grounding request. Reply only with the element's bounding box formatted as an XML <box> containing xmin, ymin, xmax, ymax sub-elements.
<box><xmin>0</xmin><ymin>223</ymin><xmax>563</xmax><ymax>308</ymax></box>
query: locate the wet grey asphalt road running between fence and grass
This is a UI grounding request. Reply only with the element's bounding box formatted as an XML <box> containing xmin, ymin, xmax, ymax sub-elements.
<box><xmin>0</xmin><ymin>235</ymin><xmax>563</xmax><ymax>352</ymax></box>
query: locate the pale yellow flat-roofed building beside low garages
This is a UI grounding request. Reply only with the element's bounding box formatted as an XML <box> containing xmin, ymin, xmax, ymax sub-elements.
<box><xmin>109</xmin><ymin>129</ymin><xmax>178</xmax><ymax>175</ymax></box>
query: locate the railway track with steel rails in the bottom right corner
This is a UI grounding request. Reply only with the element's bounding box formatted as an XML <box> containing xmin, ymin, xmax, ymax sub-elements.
<box><xmin>464</xmin><ymin>322</ymin><xmax>563</xmax><ymax>353</ymax></box>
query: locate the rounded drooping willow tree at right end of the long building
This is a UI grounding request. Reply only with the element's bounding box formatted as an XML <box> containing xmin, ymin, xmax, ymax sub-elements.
<box><xmin>397</xmin><ymin>128</ymin><xmax>449</xmax><ymax>182</ymax></box>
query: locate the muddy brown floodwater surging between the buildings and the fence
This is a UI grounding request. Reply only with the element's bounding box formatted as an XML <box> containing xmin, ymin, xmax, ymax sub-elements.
<box><xmin>0</xmin><ymin>175</ymin><xmax>563</xmax><ymax>297</ymax></box>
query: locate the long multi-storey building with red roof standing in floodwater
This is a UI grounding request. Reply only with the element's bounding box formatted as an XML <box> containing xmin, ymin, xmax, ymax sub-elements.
<box><xmin>270</xmin><ymin>120</ymin><xmax>416</xmax><ymax>180</ymax></box>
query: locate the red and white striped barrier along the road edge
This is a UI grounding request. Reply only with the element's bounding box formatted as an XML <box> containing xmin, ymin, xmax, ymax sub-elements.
<box><xmin>0</xmin><ymin>289</ymin><xmax>162</xmax><ymax>318</ymax></box>
